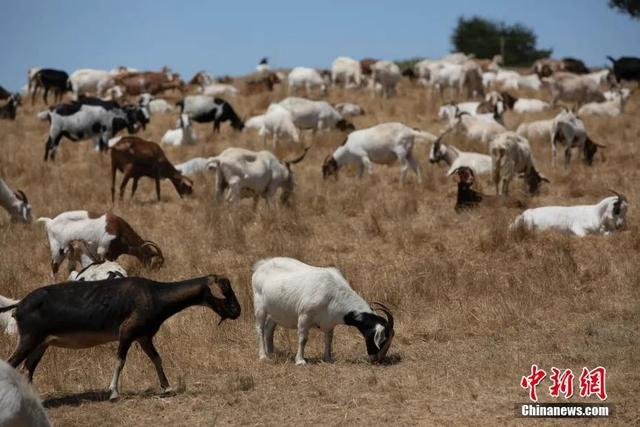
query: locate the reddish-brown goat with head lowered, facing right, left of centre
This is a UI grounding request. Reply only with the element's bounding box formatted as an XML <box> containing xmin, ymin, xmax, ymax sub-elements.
<box><xmin>111</xmin><ymin>136</ymin><xmax>193</xmax><ymax>201</ymax></box>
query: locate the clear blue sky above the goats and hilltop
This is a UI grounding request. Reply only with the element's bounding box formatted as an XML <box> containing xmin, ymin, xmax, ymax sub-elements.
<box><xmin>0</xmin><ymin>0</ymin><xmax>640</xmax><ymax>90</ymax></box>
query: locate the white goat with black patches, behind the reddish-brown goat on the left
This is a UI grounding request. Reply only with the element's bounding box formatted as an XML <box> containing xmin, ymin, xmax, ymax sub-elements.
<box><xmin>38</xmin><ymin>97</ymin><xmax>148</xmax><ymax>161</ymax></box>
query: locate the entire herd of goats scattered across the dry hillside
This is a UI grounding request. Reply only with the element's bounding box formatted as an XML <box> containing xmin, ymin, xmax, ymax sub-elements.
<box><xmin>0</xmin><ymin>53</ymin><xmax>640</xmax><ymax>425</ymax></box>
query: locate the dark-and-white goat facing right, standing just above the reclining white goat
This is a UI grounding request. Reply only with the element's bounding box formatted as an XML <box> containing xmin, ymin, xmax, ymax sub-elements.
<box><xmin>551</xmin><ymin>109</ymin><xmax>606</xmax><ymax>167</ymax></box>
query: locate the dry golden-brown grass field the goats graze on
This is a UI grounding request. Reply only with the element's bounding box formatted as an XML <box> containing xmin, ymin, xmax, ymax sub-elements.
<box><xmin>0</xmin><ymin>82</ymin><xmax>640</xmax><ymax>426</ymax></box>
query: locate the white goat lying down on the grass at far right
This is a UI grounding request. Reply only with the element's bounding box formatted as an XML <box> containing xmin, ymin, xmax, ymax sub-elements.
<box><xmin>511</xmin><ymin>190</ymin><xmax>629</xmax><ymax>237</ymax></box>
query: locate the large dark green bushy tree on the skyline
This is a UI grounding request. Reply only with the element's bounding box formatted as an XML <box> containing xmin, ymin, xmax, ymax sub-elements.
<box><xmin>451</xmin><ymin>16</ymin><xmax>552</xmax><ymax>65</ymax></box>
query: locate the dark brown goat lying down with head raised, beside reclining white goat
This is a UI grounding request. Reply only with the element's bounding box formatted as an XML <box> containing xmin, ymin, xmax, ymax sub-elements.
<box><xmin>452</xmin><ymin>166</ymin><xmax>527</xmax><ymax>213</ymax></box>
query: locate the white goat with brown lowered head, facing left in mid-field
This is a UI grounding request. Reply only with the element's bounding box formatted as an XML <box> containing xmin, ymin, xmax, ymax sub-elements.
<box><xmin>322</xmin><ymin>122</ymin><xmax>436</xmax><ymax>183</ymax></box>
